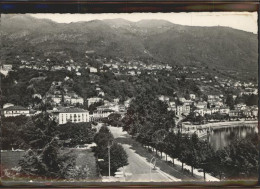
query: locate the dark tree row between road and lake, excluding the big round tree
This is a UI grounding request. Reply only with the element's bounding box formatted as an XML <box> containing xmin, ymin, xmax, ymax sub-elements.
<box><xmin>136</xmin><ymin>130</ymin><xmax>259</xmax><ymax>179</ymax></box>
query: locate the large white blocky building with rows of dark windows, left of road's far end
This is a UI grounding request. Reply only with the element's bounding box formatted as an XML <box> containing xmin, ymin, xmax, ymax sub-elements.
<box><xmin>53</xmin><ymin>107</ymin><xmax>89</xmax><ymax>124</ymax></box>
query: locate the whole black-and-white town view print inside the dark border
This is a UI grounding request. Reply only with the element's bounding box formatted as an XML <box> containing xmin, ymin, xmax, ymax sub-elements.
<box><xmin>0</xmin><ymin>12</ymin><xmax>259</xmax><ymax>184</ymax></box>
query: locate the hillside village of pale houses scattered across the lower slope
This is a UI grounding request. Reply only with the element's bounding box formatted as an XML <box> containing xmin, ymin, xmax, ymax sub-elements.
<box><xmin>1</xmin><ymin>51</ymin><xmax>258</xmax><ymax>127</ymax></box>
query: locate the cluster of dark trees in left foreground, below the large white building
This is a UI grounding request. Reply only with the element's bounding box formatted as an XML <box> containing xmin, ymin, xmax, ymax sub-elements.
<box><xmin>1</xmin><ymin>113</ymin><xmax>95</xmax><ymax>179</ymax></box>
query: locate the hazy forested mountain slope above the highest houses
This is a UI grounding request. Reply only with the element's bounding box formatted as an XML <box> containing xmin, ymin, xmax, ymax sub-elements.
<box><xmin>1</xmin><ymin>15</ymin><xmax>258</xmax><ymax>71</ymax></box>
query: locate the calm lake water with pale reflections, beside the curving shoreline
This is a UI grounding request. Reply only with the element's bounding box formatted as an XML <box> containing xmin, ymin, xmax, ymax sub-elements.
<box><xmin>208</xmin><ymin>125</ymin><xmax>258</xmax><ymax>150</ymax></box>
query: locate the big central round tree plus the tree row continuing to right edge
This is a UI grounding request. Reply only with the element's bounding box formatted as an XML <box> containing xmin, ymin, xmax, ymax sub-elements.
<box><xmin>122</xmin><ymin>93</ymin><xmax>258</xmax><ymax>179</ymax></box>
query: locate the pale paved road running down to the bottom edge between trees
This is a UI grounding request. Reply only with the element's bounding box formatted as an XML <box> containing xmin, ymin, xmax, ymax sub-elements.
<box><xmin>109</xmin><ymin>127</ymin><xmax>179</xmax><ymax>182</ymax></box>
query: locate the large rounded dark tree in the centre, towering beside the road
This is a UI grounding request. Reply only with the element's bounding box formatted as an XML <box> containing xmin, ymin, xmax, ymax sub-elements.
<box><xmin>122</xmin><ymin>90</ymin><xmax>175</xmax><ymax>137</ymax></box>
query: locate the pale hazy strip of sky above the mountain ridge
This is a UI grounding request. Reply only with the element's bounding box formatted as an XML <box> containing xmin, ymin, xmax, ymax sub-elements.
<box><xmin>31</xmin><ymin>12</ymin><xmax>258</xmax><ymax>33</ymax></box>
